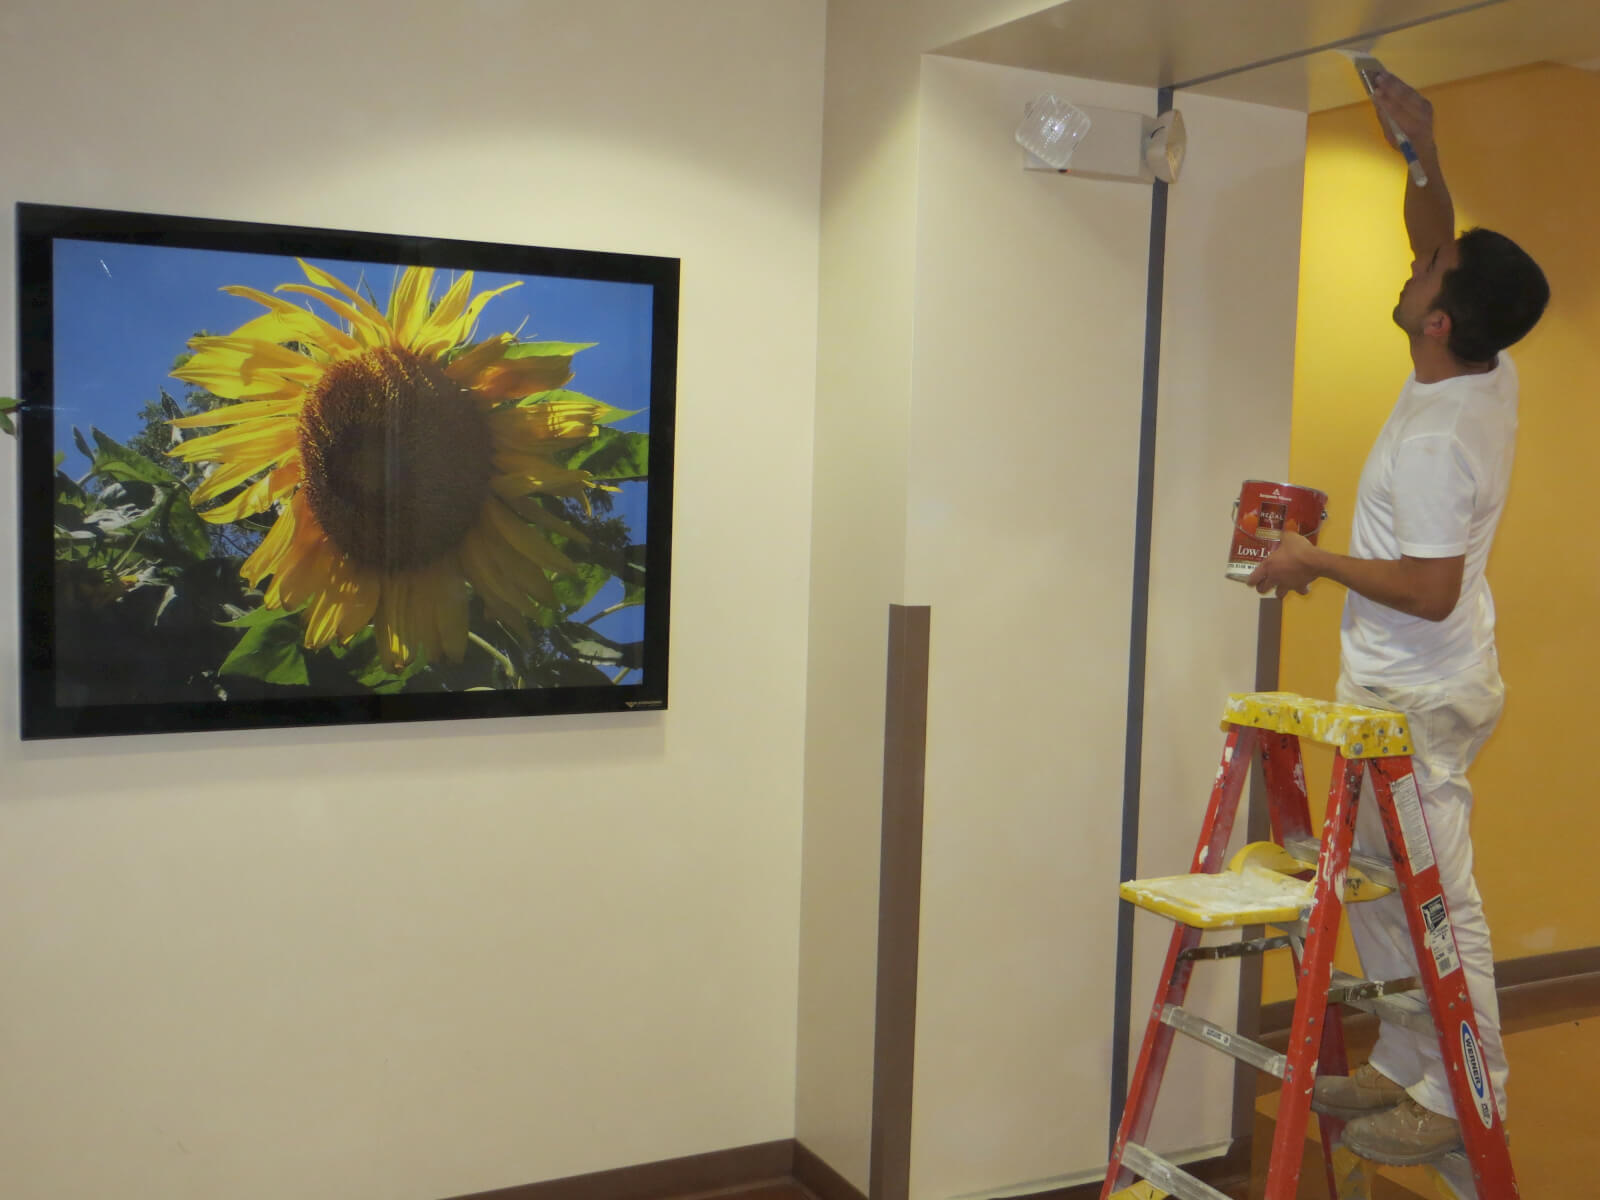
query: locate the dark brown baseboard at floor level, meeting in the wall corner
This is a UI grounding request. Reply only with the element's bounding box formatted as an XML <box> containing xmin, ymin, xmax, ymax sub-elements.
<box><xmin>438</xmin><ymin>1138</ymin><xmax>867</xmax><ymax>1200</ymax></box>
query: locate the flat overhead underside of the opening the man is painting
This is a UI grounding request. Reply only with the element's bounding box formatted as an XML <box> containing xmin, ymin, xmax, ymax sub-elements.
<box><xmin>939</xmin><ymin>0</ymin><xmax>1600</xmax><ymax>112</ymax></box>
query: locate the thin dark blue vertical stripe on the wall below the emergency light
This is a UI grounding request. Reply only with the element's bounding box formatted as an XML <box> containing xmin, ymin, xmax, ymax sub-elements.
<box><xmin>1107</xmin><ymin>88</ymin><xmax>1173</xmax><ymax>1154</ymax></box>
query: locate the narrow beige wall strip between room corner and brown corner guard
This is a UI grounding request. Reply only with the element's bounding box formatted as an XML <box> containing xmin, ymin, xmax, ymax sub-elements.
<box><xmin>797</xmin><ymin>0</ymin><xmax>1068</xmax><ymax>1189</ymax></box>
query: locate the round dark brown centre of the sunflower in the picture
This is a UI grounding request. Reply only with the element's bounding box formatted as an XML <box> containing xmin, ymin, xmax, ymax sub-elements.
<box><xmin>299</xmin><ymin>349</ymin><xmax>491</xmax><ymax>571</ymax></box>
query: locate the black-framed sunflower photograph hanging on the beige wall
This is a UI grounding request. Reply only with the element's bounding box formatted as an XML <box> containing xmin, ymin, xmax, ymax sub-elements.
<box><xmin>18</xmin><ymin>205</ymin><xmax>678</xmax><ymax>738</ymax></box>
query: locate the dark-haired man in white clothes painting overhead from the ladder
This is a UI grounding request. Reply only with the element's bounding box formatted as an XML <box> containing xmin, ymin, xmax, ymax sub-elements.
<box><xmin>1250</xmin><ymin>65</ymin><xmax>1549</xmax><ymax>1194</ymax></box>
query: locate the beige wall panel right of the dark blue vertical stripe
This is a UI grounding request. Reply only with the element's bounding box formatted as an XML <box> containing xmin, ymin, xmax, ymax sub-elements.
<box><xmin>1130</xmin><ymin>93</ymin><xmax>1306</xmax><ymax>1149</ymax></box>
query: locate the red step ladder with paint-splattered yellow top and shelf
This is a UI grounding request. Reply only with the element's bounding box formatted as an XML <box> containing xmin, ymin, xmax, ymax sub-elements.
<box><xmin>1101</xmin><ymin>691</ymin><xmax>1518</xmax><ymax>1200</ymax></box>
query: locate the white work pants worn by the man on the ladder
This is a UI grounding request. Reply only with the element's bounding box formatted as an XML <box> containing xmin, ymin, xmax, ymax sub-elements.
<box><xmin>1338</xmin><ymin>653</ymin><xmax>1509</xmax><ymax>1120</ymax></box>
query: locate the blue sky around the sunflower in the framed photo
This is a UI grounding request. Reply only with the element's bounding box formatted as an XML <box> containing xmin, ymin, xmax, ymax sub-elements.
<box><xmin>53</xmin><ymin>238</ymin><xmax>653</xmax><ymax>652</ymax></box>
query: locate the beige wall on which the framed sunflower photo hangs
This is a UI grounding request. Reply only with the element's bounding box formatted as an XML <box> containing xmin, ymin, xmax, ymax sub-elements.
<box><xmin>0</xmin><ymin>0</ymin><xmax>824</xmax><ymax>1200</ymax></box>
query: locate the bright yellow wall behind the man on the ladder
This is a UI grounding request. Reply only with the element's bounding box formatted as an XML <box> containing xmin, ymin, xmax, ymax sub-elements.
<box><xmin>1264</xmin><ymin>66</ymin><xmax>1600</xmax><ymax>1000</ymax></box>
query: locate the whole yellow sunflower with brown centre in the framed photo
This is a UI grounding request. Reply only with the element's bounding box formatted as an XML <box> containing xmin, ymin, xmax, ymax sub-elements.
<box><xmin>170</xmin><ymin>261</ymin><xmax>618</xmax><ymax>672</ymax></box>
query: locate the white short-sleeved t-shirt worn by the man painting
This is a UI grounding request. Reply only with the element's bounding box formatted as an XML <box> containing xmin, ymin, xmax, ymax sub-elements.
<box><xmin>1339</xmin><ymin>352</ymin><xmax>1517</xmax><ymax>686</ymax></box>
